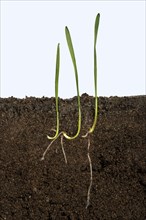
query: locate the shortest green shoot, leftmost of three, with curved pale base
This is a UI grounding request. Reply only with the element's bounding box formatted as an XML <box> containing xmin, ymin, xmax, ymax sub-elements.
<box><xmin>47</xmin><ymin>44</ymin><xmax>60</xmax><ymax>140</ymax></box>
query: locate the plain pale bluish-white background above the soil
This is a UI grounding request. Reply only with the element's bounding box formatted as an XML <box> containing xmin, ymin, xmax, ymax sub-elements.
<box><xmin>1</xmin><ymin>1</ymin><xmax>145</xmax><ymax>98</ymax></box>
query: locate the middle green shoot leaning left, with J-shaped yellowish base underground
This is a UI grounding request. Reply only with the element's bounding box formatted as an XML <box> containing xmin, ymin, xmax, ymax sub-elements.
<box><xmin>63</xmin><ymin>27</ymin><xmax>81</xmax><ymax>140</ymax></box>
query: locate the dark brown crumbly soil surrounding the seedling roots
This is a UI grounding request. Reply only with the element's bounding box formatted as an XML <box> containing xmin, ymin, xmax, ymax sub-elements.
<box><xmin>0</xmin><ymin>94</ymin><xmax>146</xmax><ymax>220</ymax></box>
